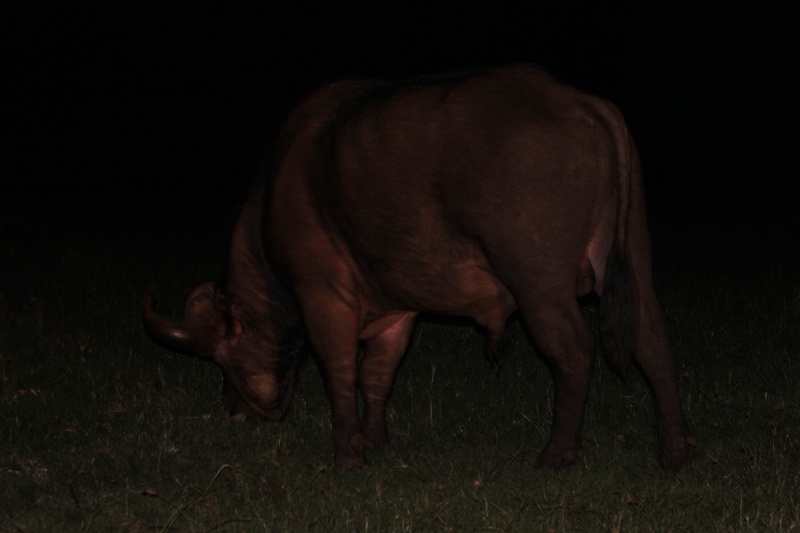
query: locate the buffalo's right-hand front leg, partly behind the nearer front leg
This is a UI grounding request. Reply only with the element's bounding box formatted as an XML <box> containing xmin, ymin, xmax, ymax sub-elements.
<box><xmin>358</xmin><ymin>313</ymin><xmax>417</xmax><ymax>452</ymax></box>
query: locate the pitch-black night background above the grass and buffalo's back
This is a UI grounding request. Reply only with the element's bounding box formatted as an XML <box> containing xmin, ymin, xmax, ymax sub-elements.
<box><xmin>0</xmin><ymin>2</ymin><xmax>800</xmax><ymax>234</ymax></box>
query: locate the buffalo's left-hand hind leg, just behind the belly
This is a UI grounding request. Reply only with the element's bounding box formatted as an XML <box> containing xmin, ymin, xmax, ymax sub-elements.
<box><xmin>520</xmin><ymin>301</ymin><xmax>594</xmax><ymax>470</ymax></box>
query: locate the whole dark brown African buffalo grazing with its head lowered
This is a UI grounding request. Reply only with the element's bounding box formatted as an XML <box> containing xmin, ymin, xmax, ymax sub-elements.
<box><xmin>142</xmin><ymin>66</ymin><xmax>695</xmax><ymax>468</ymax></box>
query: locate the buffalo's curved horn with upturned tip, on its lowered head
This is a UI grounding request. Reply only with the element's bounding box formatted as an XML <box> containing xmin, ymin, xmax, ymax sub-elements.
<box><xmin>142</xmin><ymin>287</ymin><xmax>222</xmax><ymax>358</ymax></box>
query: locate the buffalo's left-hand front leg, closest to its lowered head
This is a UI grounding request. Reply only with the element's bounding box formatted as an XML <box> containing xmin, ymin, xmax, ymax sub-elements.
<box><xmin>301</xmin><ymin>293</ymin><xmax>372</xmax><ymax>468</ymax></box>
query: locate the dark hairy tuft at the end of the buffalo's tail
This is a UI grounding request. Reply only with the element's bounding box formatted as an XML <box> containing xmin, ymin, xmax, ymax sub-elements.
<box><xmin>600</xmin><ymin>239</ymin><xmax>638</xmax><ymax>379</ymax></box>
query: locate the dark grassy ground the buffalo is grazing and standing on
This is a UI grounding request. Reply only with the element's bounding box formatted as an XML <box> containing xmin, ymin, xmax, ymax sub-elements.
<box><xmin>0</xmin><ymin>201</ymin><xmax>800</xmax><ymax>532</ymax></box>
